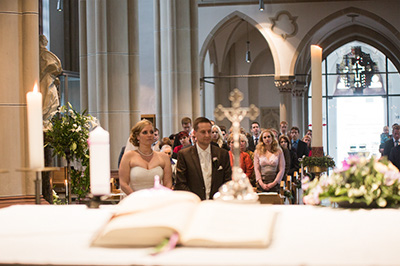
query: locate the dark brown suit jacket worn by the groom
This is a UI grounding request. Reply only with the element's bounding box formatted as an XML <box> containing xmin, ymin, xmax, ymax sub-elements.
<box><xmin>175</xmin><ymin>145</ymin><xmax>232</xmax><ymax>200</ymax></box>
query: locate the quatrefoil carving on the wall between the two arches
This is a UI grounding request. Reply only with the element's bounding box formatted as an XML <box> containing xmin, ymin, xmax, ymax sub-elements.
<box><xmin>269</xmin><ymin>10</ymin><xmax>298</xmax><ymax>40</ymax></box>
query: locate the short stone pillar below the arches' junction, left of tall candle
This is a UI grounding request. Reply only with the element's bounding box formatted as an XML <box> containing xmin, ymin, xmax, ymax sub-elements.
<box><xmin>292</xmin><ymin>81</ymin><xmax>308</xmax><ymax>135</ymax></box>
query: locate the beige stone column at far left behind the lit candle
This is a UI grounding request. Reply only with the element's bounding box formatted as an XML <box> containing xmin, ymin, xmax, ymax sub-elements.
<box><xmin>0</xmin><ymin>0</ymin><xmax>39</xmax><ymax>196</ymax></box>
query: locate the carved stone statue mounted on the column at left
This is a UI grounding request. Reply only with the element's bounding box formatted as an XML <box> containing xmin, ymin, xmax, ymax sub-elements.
<box><xmin>39</xmin><ymin>35</ymin><xmax>62</xmax><ymax>127</ymax></box>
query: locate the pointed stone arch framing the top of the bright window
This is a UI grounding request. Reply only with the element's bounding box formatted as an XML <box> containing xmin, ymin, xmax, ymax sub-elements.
<box><xmin>291</xmin><ymin>7</ymin><xmax>400</xmax><ymax>85</ymax></box>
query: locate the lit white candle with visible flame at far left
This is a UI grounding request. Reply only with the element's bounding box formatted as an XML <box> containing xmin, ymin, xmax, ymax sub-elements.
<box><xmin>26</xmin><ymin>84</ymin><xmax>44</xmax><ymax>169</ymax></box>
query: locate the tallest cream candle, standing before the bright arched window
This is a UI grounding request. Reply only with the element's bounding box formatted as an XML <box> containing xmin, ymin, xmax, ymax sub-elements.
<box><xmin>311</xmin><ymin>45</ymin><xmax>323</xmax><ymax>147</ymax></box>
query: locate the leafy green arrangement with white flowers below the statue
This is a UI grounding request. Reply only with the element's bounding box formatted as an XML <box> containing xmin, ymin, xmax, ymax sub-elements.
<box><xmin>44</xmin><ymin>103</ymin><xmax>97</xmax><ymax>199</ymax></box>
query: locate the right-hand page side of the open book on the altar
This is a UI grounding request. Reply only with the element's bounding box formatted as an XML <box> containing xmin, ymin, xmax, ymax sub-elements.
<box><xmin>181</xmin><ymin>201</ymin><xmax>276</xmax><ymax>247</ymax></box>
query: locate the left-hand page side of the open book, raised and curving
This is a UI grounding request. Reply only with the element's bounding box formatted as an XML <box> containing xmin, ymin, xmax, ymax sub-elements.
<box><xmin>92</xmin><ymin>189</ymin><xmax>200</xmax><ymax>247</ymax></box>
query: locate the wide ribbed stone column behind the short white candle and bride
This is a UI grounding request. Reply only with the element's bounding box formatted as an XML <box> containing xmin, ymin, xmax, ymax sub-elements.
<box><xmin>79</xmin><ymin>0</ymin><xmax>140</xmax><ymax>169</ymax></box>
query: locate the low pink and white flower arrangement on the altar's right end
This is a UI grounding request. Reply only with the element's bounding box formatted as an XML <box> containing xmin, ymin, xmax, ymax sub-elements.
<box><xmin>302</xmin><ymin>156</ymin><xmax>400</xmax><ymax>208</ymax></box>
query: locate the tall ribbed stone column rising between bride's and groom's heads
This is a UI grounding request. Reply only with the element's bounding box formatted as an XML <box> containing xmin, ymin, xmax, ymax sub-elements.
<box><xmin>154</xmin><ymin>0</ymin><xmax>200</xmax><ymax>136</ymax></box>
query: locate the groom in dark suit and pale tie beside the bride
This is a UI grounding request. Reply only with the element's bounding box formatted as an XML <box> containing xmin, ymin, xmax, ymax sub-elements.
<box><xmin>175</xmin><ymin>117</ymin><xmax>232</xmax><ymax>200</ymax></box>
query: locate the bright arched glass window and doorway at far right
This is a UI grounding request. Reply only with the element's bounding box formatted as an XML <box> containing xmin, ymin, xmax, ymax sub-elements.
<box><xmin>308</xmin><ymin>41</ymin><xmax>400</xmax><ymax>165</ymax></box>
